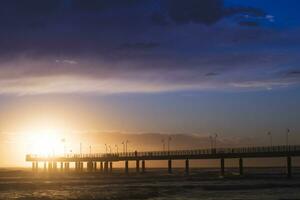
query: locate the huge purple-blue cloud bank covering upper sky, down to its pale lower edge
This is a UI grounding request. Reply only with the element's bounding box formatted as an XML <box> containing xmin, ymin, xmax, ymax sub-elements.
<box><xmin>0</xmin><ymin>0</ymin><xmax>300</xmax><ymax>94</ymax></box>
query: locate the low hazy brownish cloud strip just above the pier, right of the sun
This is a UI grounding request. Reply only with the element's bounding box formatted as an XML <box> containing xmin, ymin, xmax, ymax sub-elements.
<box><xmin>69</xmin><ymin>131</ymin><xmax>265</xmax><ymax>151</ymax></box>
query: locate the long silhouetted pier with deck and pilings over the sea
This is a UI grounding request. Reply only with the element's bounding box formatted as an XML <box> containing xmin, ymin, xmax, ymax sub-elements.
<box><xmin>26</xmin><ymin>145</ymin><xmax>300</xmax><ymax>177</ymax></box>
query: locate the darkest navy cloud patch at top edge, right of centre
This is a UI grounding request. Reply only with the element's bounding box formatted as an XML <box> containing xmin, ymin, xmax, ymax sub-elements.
<box><xmin>152</xmin><ymin>0</ymin><xmax>265</xmax><ymax>25</ymax></box>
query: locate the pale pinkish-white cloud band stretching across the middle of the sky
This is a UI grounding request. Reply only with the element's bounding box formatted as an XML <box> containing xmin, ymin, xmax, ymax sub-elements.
<box><xmin>0</xmin><ymin>50</ymin><xmax>300</xmax><ymax>95</ymax></box>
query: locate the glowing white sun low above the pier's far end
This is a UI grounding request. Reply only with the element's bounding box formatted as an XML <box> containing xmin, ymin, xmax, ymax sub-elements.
<box><xmin>26</xmin><ymin>129</ymin><xmax>64</xmax><ymax>156</ymax></box>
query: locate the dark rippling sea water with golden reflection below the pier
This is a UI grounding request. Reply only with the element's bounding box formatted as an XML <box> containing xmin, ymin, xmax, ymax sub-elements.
<box><xmin>0</xmin><ymin>169</ymin><xmax>300</xmax><ymax>200</ymax></box>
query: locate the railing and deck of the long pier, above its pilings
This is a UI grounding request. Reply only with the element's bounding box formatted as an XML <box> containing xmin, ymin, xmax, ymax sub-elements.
<box><xmin>26</xmin><ymin>145</ymin><xmax>300</xmax><ymax>161</ymax></box>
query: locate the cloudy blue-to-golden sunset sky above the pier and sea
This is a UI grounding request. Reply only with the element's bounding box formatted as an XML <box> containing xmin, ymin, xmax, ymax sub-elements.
<box><xmin>0</xmin><ymin>0</ymin><xmax>300</xmax><ymax>166</ymax></box>
